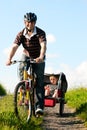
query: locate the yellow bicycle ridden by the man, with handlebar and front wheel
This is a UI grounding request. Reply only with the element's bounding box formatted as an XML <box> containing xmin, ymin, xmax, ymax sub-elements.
<box><xmin>12</xmin><ymin>59</ymin><xmax>36</xmax><ymax>122</ymax></box>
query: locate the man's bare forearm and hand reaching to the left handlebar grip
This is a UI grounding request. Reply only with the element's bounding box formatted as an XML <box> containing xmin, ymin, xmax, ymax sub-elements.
<box><xmin>6</xmin><ymin>44</ymin><xmax>18</xmax><ymax>65</ymax></box>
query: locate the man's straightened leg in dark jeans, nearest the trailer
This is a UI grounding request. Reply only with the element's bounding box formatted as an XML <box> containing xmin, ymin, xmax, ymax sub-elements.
<box><xmin>34</xmin><ymin>62</ymin><xmax>45</xmax><ymax>114</ymax></box>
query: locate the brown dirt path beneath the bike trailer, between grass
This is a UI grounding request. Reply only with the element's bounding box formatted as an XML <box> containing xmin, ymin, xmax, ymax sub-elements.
<box><xmin>43</xmin><ymin>104</ymin><xmax>87</xmax><ymax>130</ymax></box>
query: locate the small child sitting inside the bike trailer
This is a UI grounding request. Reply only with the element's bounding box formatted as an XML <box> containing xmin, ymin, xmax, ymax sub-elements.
<box><xmin>45</xmin><ymin>75</ymin><xmax>58</xmax><ymax>98</ymax></box>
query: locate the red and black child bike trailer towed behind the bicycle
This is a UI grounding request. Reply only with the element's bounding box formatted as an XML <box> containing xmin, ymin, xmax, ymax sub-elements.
<box><xmin>44</xmin><ymin>72</ymin><xmax>68</xmax><ymax>116</ymax></box>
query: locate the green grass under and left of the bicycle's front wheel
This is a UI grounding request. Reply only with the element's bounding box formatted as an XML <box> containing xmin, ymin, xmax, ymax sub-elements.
<box><xmin>0</xmin><ymin>95</ymin><xmax>43</xmax><ymax>130</ymax></box>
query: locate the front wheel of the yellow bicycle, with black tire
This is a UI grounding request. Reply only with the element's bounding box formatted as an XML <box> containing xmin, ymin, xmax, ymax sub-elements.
<box><xmin>14</xmin><ymin>81</ymin><xmax>32</xmax><ymax>122</ymax></box>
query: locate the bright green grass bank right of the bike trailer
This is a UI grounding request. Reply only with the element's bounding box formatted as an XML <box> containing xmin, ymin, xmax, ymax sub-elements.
<box><xmin>66</xmin><ymin>87</ymin><xmax>87</xmax><ymax>126</ymax></box>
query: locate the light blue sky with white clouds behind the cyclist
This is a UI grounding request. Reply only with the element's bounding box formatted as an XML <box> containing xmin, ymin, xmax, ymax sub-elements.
<box><xmin>0</xmin><ymin>0</ymin><xmax>87</xmax><ymax>92</ymax></box>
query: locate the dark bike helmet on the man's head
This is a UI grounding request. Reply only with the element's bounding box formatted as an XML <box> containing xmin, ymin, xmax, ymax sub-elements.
<box><xmin>24</xmin><ymin>12</ymin><xmax>37</xmax><ymax>22</ymax></box>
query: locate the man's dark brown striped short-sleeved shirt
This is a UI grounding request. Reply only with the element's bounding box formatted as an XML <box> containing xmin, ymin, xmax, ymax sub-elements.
<box><xmin>14</xmin><ymin>27</ymin><xmax>46</xmax><ymax>59</ymax></box>
